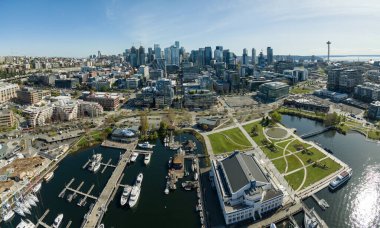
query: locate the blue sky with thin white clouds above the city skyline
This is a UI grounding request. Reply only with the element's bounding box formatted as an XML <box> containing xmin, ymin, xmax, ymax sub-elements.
<box><xmin>0</xmin><ymin>0</ymin><xmax>380</xmax><ymax>57</ymax></box>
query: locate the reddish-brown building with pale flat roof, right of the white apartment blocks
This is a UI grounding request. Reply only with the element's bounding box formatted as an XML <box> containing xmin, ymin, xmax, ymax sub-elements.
<box><xmin>82</xmin><ymin>92</ymin><xmax>120</xmax><ymax>111</ymax></box>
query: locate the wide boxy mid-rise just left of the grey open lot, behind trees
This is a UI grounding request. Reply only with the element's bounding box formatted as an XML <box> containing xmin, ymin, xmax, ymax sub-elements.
<box><xmin>183</xmin><ymin>89</ymin><xmax>217</xmax><ymax>109</ymax></box>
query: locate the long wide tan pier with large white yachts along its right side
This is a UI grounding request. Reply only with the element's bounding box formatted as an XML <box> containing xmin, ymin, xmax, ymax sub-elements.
<box><xmin>82</xmin><ymin>142</ymin><xmax>136</xmax><ymax>228</ymax></box>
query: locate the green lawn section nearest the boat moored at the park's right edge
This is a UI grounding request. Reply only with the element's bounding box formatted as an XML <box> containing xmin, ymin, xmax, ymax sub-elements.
<box><xmin>302</xmin><ymin>158</ymin><xmax>341</xmax><ymax>188</ymax></box>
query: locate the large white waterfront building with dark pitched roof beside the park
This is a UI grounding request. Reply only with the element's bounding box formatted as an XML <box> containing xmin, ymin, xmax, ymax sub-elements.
<box><xmin>210</xmin><ymin>152</ymin><xmax>284</xmax><ymax>225</ymax></box>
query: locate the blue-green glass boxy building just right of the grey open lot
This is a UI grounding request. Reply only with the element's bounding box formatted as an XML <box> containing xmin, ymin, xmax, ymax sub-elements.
<box><xmin>257</xmin><ymin>82</ymin><xmax>289</xmax><ymax>102</ymax></box>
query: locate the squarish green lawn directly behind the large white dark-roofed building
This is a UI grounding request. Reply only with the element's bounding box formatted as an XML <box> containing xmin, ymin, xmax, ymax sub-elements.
<box><xmin>208</xmin><ymin>128</ymin><xmax>252</xmax><ymax>154</ymax></box>
